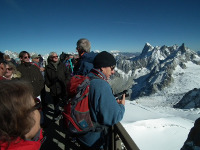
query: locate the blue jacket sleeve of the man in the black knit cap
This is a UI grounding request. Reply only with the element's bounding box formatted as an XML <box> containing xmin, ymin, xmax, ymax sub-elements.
<box><xmin>90</xmin><ymin>79</ymin><xmax>125</xmax><ymax>125</ymax></box>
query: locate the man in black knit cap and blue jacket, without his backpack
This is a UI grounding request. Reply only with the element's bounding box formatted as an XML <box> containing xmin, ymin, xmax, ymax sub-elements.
<box><xmin>77</xmin><ymin>51</ymin><xmax>125</xmax><ymax>150</ymax></box>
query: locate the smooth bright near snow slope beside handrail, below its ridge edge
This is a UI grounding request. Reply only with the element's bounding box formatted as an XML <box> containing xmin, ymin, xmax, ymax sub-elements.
<box><xmin>121</xmin><ymin>100</ymin><xmax>200</xmax><ymax>150</ymax></box>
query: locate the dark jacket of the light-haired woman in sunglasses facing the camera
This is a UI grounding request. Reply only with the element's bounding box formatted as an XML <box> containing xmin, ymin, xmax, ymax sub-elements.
<box><xmin>45</xmin><ymin>62</ymin><xmax>70</xmax><ymax>96</ymax></box>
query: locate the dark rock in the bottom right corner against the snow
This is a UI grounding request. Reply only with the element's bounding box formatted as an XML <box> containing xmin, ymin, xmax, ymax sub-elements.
<box><xmin>181</xmin><ymin>118</ymin><xmax>200</xmax><ymax>150</ymax></box>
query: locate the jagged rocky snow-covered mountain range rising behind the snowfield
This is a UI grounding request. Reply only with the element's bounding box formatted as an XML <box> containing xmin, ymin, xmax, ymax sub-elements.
<box><xmin>111</xmin><ymin>43</ymin><xmax>200</xmax><ymax>103</ymax></box>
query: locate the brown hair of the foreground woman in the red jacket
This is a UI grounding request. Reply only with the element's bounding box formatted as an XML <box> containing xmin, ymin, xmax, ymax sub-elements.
<box><xmin>0</xmin><ymin>80</ymin><xmax>35</xmax><ymax>142</ymax></box>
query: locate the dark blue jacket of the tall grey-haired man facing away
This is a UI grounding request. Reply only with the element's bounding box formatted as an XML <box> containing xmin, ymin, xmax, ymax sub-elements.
<box><xmin>74</xmin><ymin>52</ymin><xmax>98</xmax><ymax>75</ymax></box>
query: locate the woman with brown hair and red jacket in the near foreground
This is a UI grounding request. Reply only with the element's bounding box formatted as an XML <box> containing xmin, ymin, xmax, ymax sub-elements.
<box><xmin>0</xmin><ymin>80</ymin><xmax>43</xmax><ymax>150</ymax></box>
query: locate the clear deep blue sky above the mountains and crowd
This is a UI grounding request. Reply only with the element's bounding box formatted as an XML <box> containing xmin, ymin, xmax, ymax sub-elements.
<box><xmin>0</xmin><ymin>0</ymin><xmax>200</xmax><ymax>54</ymax></box>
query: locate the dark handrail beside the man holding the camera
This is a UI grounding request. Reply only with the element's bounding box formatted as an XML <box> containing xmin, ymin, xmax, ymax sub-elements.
<box><xmin>112</xmin><ymin>122</ymin><xmax>139</xmax><ymax>150</ymax></box>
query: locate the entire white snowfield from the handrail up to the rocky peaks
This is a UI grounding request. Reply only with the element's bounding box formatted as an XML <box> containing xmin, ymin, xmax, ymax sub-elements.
<box><xmin>121</xmin><ymin>62</ymin><xmax>200</xmax><ymax>150</ymax></box>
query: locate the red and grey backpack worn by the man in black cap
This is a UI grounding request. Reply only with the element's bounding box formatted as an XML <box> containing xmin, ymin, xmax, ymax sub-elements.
<box><xmin>62</xmin><ymin>75</ymin><xmax>95</xmax><ymax>134</ymax></box>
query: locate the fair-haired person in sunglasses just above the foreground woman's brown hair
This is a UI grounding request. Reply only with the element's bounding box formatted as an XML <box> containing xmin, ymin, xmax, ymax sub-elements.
<box><xmin>4</xmin><ymin>62</ymin><xmax>21</xmax><ymax>80</ymax></box>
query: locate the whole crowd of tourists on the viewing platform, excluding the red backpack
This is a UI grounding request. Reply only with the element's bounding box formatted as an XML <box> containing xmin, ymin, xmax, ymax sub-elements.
<box><xmin>0</xmin><ymin>38</ymin><xmax>125</xmax><ymax>150</ymax></box>
